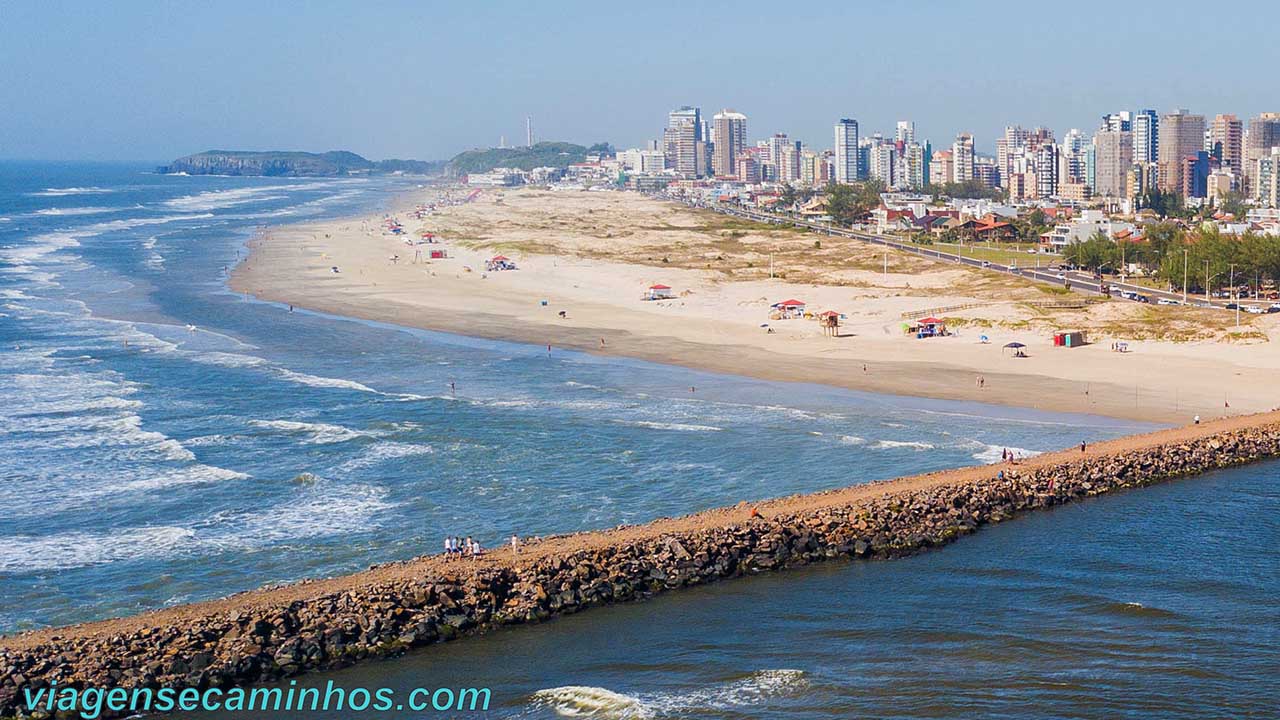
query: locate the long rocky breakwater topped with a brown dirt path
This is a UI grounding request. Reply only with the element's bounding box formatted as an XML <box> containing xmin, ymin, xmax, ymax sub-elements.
<box><xmin>0</xmin><ymin>414</ymin><xmax>1280</xmax><ymax>717</ymax></box>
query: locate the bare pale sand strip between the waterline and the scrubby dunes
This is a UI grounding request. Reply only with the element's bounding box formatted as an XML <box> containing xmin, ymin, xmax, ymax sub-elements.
<box><xmin>227</xmin><ymin>184</ymin><xmax>1280</xmax><ymax>425</ymax></box>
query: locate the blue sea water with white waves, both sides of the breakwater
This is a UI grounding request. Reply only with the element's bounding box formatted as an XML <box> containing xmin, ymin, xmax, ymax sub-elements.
<box><xmin>0</xmin><ymin>163</ymin><xmax>1280</xmax><ymax>717</ymax></box>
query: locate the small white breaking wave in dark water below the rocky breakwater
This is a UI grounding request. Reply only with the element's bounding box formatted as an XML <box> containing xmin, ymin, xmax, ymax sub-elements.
<box><xmin>530</xmin><ymin>670</ymin><xmax>810</xmax><ymax>720</ymax></box>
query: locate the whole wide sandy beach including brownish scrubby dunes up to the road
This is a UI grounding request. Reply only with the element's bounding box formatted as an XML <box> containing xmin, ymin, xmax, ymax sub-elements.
<box><xmin>230</xmin><ymin>187</ymin><xmax>1280</xmax><ymax>424</ymax></box>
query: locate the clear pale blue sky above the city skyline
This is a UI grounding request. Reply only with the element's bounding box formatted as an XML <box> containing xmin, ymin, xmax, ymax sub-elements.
<box><xmin>0</xmin><ymin>0</ymin><xmax>1280</xmax><ymax>161</ymax></box>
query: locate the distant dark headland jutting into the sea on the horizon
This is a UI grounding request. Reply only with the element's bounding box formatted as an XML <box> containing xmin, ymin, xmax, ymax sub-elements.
<box><xmin>156</xmin><ymin>150</ymin><xmax>442</xmax><ymax>177</ymax></box>
